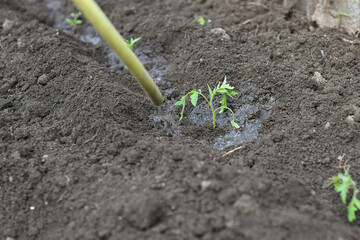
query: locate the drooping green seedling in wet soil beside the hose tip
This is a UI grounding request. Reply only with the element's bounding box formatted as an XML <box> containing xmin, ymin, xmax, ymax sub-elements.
<box><xmin>175</xmin><ymin>76</ymin><xmax>239</xmax><ymax>128</ymax></box>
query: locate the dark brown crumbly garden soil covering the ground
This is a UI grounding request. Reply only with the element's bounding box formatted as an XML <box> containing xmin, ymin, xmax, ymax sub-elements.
<box><xmin>0</xmin><ymin>0</ymin><xmax>360</xmax><ymax>240</ymax></box>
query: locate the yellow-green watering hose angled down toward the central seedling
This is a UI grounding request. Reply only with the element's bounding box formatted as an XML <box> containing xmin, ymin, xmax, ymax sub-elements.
<box><xmin>72</xmin><ymin>0</ymin><xmax>164</xmax><ymax>106</ymax></box>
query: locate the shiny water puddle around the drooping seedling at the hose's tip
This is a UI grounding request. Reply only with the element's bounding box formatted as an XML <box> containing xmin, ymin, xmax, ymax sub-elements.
<box><xmin>153</xmin><ymin>84</ymin><xmax>275</xmax><ymax>150</ymax></box>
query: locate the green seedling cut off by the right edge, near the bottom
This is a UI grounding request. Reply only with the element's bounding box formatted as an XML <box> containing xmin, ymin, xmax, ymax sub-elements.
<box><xmin>326</xmin><ymin>166</ymin><xmax>360</xmax><ymax>222</ymax></box>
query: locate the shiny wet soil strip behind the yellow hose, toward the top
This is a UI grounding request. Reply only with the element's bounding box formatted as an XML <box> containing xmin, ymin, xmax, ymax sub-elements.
<box><xmin>35</xmin><ymin>0</ymin><xmax>170</xmax><ymax>83</ymax></box>
